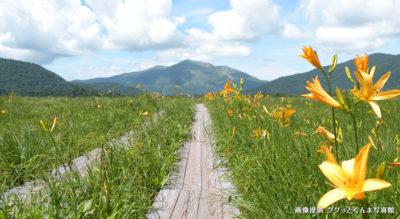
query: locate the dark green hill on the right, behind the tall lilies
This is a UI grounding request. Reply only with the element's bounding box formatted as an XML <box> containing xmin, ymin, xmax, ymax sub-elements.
<box><xmin>246</xmin><ymin>53</ymin><xmax>400</xmax><ymax>94</ymax></box>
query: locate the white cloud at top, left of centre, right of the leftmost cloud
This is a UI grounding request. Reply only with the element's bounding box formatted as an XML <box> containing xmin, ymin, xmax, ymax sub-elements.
<box><xmin>86</xmin><ymin>0</ymin><xmax>185</xmax><ymax>51</ymax></box>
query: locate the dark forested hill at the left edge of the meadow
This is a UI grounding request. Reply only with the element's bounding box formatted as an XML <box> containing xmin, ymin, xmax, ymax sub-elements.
<box><xmin>0</xmin><ymin>58</ymin><xmax>98</xmax><ymax>96</ymax></box>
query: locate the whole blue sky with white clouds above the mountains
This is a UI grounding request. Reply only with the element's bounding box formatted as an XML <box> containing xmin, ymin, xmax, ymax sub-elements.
<box><xmin>0</xmin><ymin>0</ymin><xmax>400</xmax><ymax>80</ymax></box>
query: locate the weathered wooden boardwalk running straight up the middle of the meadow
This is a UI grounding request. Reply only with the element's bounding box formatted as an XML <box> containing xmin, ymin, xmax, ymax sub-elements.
<box><xmin>147</xmin><ymin>104</ymin><xmax>239</xmax><ymax>219</ymax></box>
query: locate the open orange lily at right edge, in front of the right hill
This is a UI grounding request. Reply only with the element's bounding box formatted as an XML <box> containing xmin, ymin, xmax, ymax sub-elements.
<box><xmin>351</xmin><ymin>66</ymin><xmax>400</xmax><ymax>118</ymax></box>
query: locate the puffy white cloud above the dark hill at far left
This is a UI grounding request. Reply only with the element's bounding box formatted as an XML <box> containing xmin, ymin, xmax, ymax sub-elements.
<box><xmin>0</xmin><ymin>0</ymin><xmax>102</xmax><ymax>63</ymax></box>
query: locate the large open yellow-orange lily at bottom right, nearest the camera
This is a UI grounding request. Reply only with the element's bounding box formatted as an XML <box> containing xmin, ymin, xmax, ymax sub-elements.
<box><xmin>317</xmin><ymin>144</ymin><xmax>392</xmax><ymax>208</ymax></box>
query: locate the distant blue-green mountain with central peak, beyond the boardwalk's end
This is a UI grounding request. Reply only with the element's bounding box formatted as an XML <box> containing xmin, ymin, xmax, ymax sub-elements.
<box><xmin>76</xmin><ymin>59</ymin><xmax>265</xmax><ymax>94</ymax></box>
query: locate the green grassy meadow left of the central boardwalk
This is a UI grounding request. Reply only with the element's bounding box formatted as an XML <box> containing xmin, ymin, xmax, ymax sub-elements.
<box><xmin>0</xmin><ymin>95</ymin><xmax>194</xmax><ymax>218</ymax></box>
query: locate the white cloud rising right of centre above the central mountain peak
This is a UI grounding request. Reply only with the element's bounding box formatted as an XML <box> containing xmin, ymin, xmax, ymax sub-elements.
<box><xmin>158</xmin><ymin>0</ymin><xmax>279</xmax><ymax>61</ymax></box>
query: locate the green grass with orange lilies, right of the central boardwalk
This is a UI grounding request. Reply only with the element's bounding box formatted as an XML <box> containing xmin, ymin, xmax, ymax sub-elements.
<box><xmin>207</xmin><ymin>95</ymin><xmax>400</xmax><ymax>218</ymax></box>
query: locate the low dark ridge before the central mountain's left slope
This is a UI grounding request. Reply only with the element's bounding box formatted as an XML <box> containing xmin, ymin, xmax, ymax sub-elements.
<box><xmin>71</xmin><ymin>82</ymin><xmax>142</xmax><ymax>95</ymax></box>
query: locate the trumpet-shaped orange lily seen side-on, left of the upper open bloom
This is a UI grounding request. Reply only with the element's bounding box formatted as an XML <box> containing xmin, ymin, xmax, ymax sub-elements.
<box><xmin>301</xmin><ymin>76</ymin><xmax>342</xmax><ymax>108</ymax></box>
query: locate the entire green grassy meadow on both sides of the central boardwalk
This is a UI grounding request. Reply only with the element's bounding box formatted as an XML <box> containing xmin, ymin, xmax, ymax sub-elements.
<box><xmin>0</xmin><ymin>85</ymin><xmax>400</xmax><ymax>218</ymax></box>
